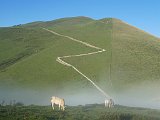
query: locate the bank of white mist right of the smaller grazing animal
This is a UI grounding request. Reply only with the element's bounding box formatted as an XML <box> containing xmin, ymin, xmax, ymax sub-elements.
<box><xmin>114</xmin><ymin>82</ymin><xmax>160</xmax><ymax>109</ymax></box>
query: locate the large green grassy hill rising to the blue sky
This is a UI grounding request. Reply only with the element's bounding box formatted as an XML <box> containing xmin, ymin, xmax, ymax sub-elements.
<box><xmin>0</xmin><ymin>17</ymin><xmax>160</xmax><ymax>107</ymax></box>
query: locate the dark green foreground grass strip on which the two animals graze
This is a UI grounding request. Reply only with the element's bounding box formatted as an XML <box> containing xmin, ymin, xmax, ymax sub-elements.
<box><xmin>0</xmin><ymin>104</ymin><xmax>160</xmax><ymax>120</ymax></box>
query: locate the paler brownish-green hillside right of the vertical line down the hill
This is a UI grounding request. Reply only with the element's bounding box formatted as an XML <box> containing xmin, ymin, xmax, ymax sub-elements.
<box><xmin>112</xmin><ymin>20</ymin><xmax>160</xmax><ymax>87</ymax></box>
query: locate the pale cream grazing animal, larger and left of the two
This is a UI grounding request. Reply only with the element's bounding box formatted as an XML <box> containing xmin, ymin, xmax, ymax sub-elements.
<box><xmin>51</xmin><ymin>96</ymin><xmax>65</xmax><ymax>111</ymax></box>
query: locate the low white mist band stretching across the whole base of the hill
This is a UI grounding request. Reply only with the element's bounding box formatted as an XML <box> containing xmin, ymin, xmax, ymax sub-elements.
<box><xmin>0</xmin><ymin>82</ymin><xmax>160</xmax><ymax>109</ymax></box>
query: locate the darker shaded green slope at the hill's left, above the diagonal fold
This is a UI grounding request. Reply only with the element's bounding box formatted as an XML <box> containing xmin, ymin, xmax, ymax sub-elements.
<box><xmin>0</xmin><ymin>27</ymin><xmax>56</xmax><ymax>70</ymax></box>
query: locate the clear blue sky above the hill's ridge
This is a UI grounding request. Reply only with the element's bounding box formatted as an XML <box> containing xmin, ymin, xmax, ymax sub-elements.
<box><xmin>0</xmin><ymin>0</ymin><xmax>160</xmax><ymax>37</ymax></box>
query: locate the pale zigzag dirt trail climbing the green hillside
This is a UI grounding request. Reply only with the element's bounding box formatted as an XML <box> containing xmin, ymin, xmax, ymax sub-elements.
<box><xmin>43</xmin><ymin>28</ymin><xmax>111</xmax><ymax>99</ymax></box>
